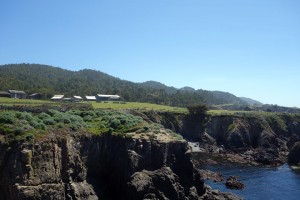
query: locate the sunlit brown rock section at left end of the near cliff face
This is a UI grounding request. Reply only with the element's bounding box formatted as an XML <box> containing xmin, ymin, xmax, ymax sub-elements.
<box><xmin>0</xmin><ymin>137</ymin><xmax>98</xmax><ymax>200</ymax></box>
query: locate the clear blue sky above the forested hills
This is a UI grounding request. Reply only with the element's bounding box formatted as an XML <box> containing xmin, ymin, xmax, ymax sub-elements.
<box><xmin>0</xmin><ymin>0</ymin><xmax>300</xmax><ymax>107</ymax></box>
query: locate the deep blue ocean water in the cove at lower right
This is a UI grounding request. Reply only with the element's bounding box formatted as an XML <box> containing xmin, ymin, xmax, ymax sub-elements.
<box><xmin>206</xmin><ymin>164</ymin><xmax>300</xmax><ymax>200</ymax></box>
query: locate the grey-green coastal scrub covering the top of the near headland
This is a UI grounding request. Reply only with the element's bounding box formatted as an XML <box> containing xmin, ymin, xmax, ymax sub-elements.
<box><xmin>0</xmin><ymin>109</ymin><xmax>182</xmax><ymax>143</ymax></box>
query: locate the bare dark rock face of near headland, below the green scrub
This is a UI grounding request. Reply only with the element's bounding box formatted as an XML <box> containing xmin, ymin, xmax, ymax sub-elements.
<box><xmin>0</xmin><ymin>135</ymin><xmax>204</xmax><ymax>200</ymax></box>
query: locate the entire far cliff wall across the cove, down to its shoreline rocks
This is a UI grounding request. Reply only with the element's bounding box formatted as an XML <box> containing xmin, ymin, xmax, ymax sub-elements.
<box><xmin>140</xmin><ymin>113</ymin><xmax>300</xmax><ymax>165</ymax></box>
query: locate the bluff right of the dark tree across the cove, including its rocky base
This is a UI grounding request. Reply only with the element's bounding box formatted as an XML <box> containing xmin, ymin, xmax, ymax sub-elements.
<box><xmin>200</xmin><ymin>115</ymin><xmax>289</xmax><ymax>166</ymax></box>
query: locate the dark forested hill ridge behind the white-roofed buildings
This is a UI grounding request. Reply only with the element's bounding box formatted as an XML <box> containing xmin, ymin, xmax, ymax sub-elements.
<box><xmin>0</xmin><ymin>64</ymin><xmax>246</xmax><ymax>106</ymax></box>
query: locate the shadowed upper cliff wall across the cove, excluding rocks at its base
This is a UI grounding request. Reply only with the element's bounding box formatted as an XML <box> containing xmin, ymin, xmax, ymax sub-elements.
<box><xmin>141</xmin><ymin>111</ymin><xmax>300</xmax><ymax>149</ymax></box>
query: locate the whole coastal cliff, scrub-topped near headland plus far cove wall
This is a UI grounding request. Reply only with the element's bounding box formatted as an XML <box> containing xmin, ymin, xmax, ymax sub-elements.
<box><xmin>0</xmin><ymin>107</ymin><xmax>299</xmax><ymax>200</ymax></box>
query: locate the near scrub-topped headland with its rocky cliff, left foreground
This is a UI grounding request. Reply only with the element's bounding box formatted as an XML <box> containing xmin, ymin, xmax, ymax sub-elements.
<box><xmin>0</xmin><ymin>109</ymin><xmax>246</xmax><ymax>200</ymax></box>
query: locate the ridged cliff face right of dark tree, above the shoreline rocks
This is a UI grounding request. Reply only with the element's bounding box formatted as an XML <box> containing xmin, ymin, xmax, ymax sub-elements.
<box><xmin>207</xmin><ymin>116</ymin><xmax>278</xmax><ymax>149</ymax></box>
